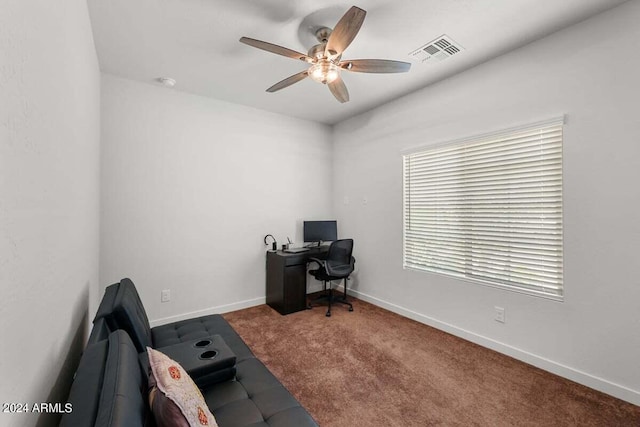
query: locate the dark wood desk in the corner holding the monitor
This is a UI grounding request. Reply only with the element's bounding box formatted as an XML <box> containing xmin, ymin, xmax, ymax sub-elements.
<box><xmin>267</xmin><ymin>246</ymin><xmax>329</xmax><ymax>314</ymax></box>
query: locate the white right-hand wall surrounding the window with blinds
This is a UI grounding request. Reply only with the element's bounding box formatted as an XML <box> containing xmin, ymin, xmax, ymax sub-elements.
<box><xmin>334</xmin><ymin>1</ymin><xmax>640</xmax><ymax>404</ymax></box>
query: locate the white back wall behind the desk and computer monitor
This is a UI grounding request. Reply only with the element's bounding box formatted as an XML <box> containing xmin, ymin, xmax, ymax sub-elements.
<box><xmin>100</xmin><ymin>75</ymin><xmax>333</xmax><ymax>324</ymax></box>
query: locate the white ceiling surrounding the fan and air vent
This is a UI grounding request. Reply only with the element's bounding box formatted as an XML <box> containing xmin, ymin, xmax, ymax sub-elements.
<box><xmin>88</xmin><ymin>0</ymin><xmax>625</xmax><ymax>124</ymax></box>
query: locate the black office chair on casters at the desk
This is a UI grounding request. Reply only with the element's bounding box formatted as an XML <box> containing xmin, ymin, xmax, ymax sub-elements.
<box><xmin>308</xmin><ymin>239</ymin><xmax>356</xmax><ymax>317</ymax></box>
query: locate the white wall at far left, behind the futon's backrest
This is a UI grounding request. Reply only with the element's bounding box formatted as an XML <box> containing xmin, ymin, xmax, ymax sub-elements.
<box><xmin>0</xmin><ymin>0</ymin><xmax>100</xmax><ymax>426</ymax></box>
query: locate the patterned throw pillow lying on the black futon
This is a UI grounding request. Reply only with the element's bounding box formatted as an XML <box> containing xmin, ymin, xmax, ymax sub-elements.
<box><xmin>147</xmin><ymin>347</ymin><xmax>218</xmax><ymax>427</ymax></box>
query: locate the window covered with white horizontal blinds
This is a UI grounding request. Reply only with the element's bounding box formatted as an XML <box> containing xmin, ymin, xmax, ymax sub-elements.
<box><xmin>404</xmin><ymin>119</ymin><xmax>563</xmax><ymax>299</ymax></box>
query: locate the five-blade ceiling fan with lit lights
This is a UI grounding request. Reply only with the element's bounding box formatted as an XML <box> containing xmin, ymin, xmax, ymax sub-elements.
<box><xmin>240</xmin><ymin>6</ymin><xmax>411</xmax><ymax>102</ymax></box>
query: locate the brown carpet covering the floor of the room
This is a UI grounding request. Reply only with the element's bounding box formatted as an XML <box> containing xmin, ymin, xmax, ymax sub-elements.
<box><xmin>224</xmin><ymin>300</ymin><xmax>640</xmax><ymax>427</ymax></box>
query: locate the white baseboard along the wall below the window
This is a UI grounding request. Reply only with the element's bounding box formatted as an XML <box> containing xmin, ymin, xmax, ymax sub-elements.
<box><xmin>348</xmin><ymin>289</ymin><xmax>640</xmax><ymax>405</ymax></box>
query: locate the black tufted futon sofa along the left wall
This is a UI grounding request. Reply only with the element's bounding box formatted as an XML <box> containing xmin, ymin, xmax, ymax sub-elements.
<box><xmin>60</xmin><ymin>279</ymin><xmax>317</xmax><ymax>427</ymax></box>
